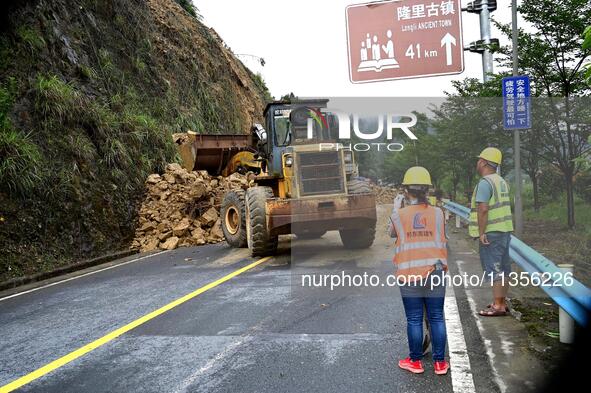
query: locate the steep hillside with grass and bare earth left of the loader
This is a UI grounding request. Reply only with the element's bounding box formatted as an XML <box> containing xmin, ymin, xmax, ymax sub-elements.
<box><xmin>0</xmin><ymin>0</ymin><xmax>269</xmax><ymax>280</ymax></box>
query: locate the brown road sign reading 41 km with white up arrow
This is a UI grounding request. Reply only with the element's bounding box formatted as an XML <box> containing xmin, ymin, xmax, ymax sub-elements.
<box><xmin>346</xmin><ymin>0</ymin><xmax>464</xmax><ymax>83</ymax></box>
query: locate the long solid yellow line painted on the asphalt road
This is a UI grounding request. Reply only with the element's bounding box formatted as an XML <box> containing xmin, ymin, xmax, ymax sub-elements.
<box><xmin>0</xmin><ymin>257</ymin><xmax>270</xmax><ymax>393</ymax></box>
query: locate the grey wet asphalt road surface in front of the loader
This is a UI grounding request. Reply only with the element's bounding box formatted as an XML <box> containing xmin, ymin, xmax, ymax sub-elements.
<box><xmin>0</xmin><ymin>207</ymin><xmax>497</xmax><ymax>393</ymax></box>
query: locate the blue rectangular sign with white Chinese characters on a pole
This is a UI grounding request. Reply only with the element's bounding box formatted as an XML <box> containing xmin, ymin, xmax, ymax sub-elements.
<box><xmin>503</xmin><ymin>75</ymin><xmax>531</xmax><ymax>130</ymax></box>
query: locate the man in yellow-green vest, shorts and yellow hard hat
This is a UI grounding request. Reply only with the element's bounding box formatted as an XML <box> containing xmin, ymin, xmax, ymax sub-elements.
<box><xmin>468</xmin><ymin>147</ymin><xmax>513</xmax><ymax>317</ymax></box>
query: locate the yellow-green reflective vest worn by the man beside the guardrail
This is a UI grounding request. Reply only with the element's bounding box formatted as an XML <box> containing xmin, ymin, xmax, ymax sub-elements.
<box><xmin>468</xmin><ymin>173</ymin><xmax>513</xmax><ymax>237</ymax></box>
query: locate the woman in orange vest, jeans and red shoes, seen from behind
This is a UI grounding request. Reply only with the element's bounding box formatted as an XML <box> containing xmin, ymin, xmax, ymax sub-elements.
<box><xmin>389</xmin><ymin>167</ymin><xmax>449</xmax><ymax>375</ymax></box>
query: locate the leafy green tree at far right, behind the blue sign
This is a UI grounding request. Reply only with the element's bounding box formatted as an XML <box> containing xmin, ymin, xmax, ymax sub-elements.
<box><xmin>497</xmin><ymin>0</ymin><xmax>591</xmax><ymax>228</ymax></box>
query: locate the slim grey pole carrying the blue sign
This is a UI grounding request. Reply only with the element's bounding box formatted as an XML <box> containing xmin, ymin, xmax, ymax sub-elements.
<box><xmin>511</xmin><ymin>0</ymin><xmax>523</xmax><ymax>237</ymax></box>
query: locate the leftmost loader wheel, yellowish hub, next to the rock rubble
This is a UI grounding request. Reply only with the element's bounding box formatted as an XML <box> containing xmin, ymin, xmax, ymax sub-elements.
<box><xmin>220</xmin><ymin>190</ymin><xmax>247</xmax><ymax>248</ymax></box>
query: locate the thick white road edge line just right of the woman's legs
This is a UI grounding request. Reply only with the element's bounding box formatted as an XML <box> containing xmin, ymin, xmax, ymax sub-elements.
<box><xmin>444</xmin><ymin>278</ymin><xmax>475</xmax><ymax>393</ymax></box>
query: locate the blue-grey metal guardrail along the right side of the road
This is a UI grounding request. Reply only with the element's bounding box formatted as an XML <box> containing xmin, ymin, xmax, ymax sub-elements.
<box><xmin>443</xmin><ymin>201</ymin><xmax>591</xmax><ymax>326</ymax></box>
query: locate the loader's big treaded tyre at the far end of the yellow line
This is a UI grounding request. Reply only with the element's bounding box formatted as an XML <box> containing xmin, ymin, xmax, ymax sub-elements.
<box><xmin>246</xmin><ymin>187</ymin><xmax>278</xmax><ymax>256</ymax></box>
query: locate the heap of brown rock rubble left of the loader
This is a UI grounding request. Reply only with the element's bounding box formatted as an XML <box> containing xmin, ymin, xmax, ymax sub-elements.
<box><xmin>131</xmin><ymin>164</ymin><xmax>248</xmax><ymax>251</ymax></box>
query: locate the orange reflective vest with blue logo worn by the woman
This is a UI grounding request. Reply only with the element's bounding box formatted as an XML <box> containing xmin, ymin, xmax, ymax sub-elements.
<box><xmin>390</xmin><ymin>204</ymin><xmax>447</xmax><ymax>281</ymax></box>
